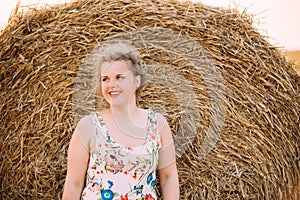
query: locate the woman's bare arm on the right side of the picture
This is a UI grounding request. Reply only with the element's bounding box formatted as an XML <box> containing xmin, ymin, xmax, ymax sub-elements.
<box><xmin>158</xmin><ymin>114</ymin><xmax>179</xmax><ymax>200</ymax></box>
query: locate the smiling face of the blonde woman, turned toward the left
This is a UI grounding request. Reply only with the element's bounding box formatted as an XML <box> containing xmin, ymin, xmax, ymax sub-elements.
<box><xmin>100</xmin><ymin>60</ymin><xmax>140</xmax><ymax>106</ymax></box>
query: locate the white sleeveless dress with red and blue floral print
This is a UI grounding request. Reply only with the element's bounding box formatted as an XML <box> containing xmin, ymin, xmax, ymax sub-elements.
<box><xmin>81</xmin><ymin>110</ymin><xmax>161</xmax><ymax>200</ymax></box>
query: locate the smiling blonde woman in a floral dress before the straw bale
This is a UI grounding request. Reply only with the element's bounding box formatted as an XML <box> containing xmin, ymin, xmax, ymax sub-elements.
<box><xmin>63</xmin><ymin>44</ymin><xmax>179</xmax><ymax>200</ymax></box>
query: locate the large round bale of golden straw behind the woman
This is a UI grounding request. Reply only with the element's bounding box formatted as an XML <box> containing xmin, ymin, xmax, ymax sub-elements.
<box><xmin>0</xmin><ymin>0</ymin><xmax>300</xmax><ymax>200</ymax></box>
